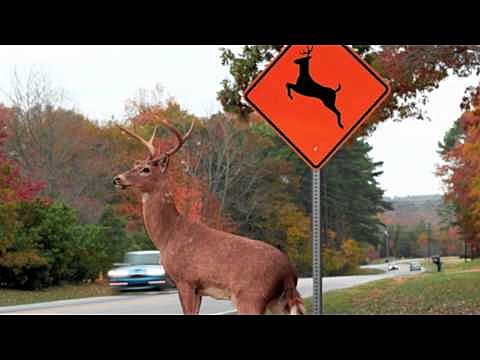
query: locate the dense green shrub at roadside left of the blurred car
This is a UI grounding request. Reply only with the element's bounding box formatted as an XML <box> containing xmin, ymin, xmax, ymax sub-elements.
<box><xmin>0</xmin><ymin>199</ymin><xmax>130</xmax><ymax>289</ymax></box>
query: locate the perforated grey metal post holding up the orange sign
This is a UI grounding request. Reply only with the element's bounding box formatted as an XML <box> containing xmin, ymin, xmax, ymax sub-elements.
<box><xmin>312</xmin><ymin>169</ymin><xmax>323</xmax><ymax>315</ymax></box>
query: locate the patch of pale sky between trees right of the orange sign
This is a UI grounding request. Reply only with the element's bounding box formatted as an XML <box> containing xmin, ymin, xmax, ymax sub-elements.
<box><xmin>367</xmin><ymin>76</ymin><xmax>479</xmax><ymax>197</ymax></box>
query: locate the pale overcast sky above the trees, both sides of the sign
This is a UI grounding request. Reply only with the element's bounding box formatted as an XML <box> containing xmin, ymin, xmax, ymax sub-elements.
<box><xmin>0</xmin><ymin>45</ymin><xmax>479</xmax><ymax>197</ymax></box>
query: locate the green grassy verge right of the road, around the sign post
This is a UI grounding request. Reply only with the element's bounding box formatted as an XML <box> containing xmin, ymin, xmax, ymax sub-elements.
<box><xmin>306</xmin><ymin>260</ymin><xmax>480</xmax><ymax>315</ymax></box>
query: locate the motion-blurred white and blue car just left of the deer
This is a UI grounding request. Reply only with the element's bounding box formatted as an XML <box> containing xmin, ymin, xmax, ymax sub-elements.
<box><xmin>108</xmin><ymin>251</ymin><xmax>175</xmax><ymax>291</ymax></box>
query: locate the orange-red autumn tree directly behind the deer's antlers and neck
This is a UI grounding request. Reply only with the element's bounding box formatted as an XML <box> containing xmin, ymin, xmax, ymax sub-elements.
<box><xmin>113</xmin><ymin>86</ymin><xmax>233</xmax><ymax>230</ymax></box>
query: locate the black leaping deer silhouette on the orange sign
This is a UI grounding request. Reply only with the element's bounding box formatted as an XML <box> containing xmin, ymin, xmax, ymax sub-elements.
<box><xmin>287</xmin><ymin>46</ymin><xmax>343</xmax><ymax>129</ymax></box>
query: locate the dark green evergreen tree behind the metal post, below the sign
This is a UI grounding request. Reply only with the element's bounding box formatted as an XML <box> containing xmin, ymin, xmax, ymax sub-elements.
<box><xmin>300</xmin><ymin>139</ymin><xmax>391</xmax><ymax>248</ymax></box>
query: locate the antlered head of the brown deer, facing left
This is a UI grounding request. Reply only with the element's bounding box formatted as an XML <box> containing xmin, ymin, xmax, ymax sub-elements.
<box><xmin>113</xmin><ymin>120</ymin><xmax>195</xmax><ymax>193</ymax></box>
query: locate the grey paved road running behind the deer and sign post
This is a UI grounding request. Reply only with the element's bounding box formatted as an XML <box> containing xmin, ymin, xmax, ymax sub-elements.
<box><xmin>0</xmin><ymin>260</ymin><xmax>420</xmax><ymax>315</ymax></box>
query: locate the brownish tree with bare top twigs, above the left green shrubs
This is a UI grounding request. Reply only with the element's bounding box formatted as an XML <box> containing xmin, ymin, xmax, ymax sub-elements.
<box><xmin>6</xmin><ymin>70</ymin><xmax>120</xmax><ymax>222</ymax></box>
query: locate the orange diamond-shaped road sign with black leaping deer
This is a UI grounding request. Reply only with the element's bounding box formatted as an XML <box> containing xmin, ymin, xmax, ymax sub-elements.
<box><xmin>245</xmin><ymin>45</ymin><xmax>390</xmax><ymax>169</ymax></box>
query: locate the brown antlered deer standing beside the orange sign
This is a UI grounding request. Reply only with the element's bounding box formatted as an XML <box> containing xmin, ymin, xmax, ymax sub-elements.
<box><xmin>113</xmin><ymin>119</ymin><xmax>305</xmax><ymax>315</ymax></box>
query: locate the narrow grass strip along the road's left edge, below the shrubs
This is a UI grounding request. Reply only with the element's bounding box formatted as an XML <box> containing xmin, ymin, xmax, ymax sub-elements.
<box><xmin>0</xmin><ymin>284</ymin><xmax>115</xmax><ymax>306</ymax></box>
